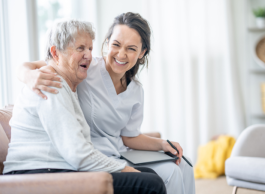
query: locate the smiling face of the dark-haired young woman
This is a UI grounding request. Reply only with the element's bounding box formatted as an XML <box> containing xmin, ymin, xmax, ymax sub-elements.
<box><xmin>106</xmin><ymin>25</ymin><xmax>145</xmax><ymax>76</ymax></box>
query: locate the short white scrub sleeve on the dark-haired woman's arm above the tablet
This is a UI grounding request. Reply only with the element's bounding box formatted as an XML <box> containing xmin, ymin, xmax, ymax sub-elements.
<box><xmin>121</xmin><ymin>88</ymin><xmax>144</xmax><ymax>137</ymax></box>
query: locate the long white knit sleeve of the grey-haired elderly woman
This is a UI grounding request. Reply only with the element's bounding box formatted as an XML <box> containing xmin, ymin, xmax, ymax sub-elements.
<box><xmin>38</xmin><ymin>86</ymin><xmax>125</xmax><ymax>173</ymax></box>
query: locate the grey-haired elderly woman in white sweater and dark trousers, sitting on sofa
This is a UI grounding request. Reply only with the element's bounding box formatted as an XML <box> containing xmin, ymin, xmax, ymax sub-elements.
<box><xmin>4</xmin><ymin>20</ymin><xmax>166</xmax><ymax>193</ymax></box>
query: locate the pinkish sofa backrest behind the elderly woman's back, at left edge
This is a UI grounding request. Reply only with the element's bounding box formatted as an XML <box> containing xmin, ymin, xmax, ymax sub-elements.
<box><xmin>0</xmin><ymin>105</ymin><xmax>13</xmax><ymax>140</ymax></box>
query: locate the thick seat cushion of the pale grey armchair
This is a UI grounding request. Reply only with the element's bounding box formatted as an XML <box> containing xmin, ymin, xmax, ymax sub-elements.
<box><xmin>225</xmin><ymin>156</ymin><xmax>265</xmax><ymax>184</ymax></box>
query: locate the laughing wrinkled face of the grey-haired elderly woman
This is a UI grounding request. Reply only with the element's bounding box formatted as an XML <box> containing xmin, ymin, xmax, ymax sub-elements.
<box><xmin>59</xmin><ymin>33</ymin><xmax>93</xmax><ymax>83</ymax></box>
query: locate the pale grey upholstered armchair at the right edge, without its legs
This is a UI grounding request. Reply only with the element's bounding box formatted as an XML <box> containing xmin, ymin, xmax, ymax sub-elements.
<box><xmin>225</xmin><ymin>124</ymin><xmax>265</xmax><ymax>191</ymax></box>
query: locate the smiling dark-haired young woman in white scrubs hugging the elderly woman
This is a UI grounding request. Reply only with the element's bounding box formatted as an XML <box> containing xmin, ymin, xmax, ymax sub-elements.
<box><xmin>19</xmin><ymin>12</ymin><xmax>195</xmax><ymax>194</ymax></box>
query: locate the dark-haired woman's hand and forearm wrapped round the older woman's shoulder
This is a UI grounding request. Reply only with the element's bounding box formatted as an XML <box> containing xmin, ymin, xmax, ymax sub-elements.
<box><xmin>17</xmin><ymin>61</ymin><xmax>62</xmax><ymax>99</ymax></box>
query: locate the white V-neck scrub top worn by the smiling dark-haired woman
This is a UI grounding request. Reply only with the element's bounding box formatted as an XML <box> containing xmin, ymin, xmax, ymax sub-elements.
<box><xmin>77</xmin><ymin>57</ymin><xmax>144</xmax><ymax>158</ymax></box>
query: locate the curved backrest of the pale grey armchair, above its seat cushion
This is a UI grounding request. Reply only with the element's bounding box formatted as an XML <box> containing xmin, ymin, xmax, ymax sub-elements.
<box><xmin>231</xmin><ymin>124</ymin><xmax>265</xmax><ymax>158</ymax></box>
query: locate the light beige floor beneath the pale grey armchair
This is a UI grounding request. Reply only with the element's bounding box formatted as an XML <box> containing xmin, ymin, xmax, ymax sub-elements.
<box><xmin>195</xmin><ymin>176</ymin><xmax>265</xmax><ymax>194</ymax></box>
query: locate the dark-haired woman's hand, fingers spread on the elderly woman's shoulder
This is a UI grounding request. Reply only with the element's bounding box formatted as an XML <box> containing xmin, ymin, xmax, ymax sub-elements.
<box><xmin>25</xmin><ymin>61</ymin><xmax>62</xmax><ymax>99</ymax></box>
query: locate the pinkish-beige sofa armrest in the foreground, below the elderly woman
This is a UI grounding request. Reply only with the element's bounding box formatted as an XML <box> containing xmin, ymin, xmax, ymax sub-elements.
<box><xmin>0</xmin><ymin>172</ymin><xmax>113</xmax><ymax>194</ymax></box>
